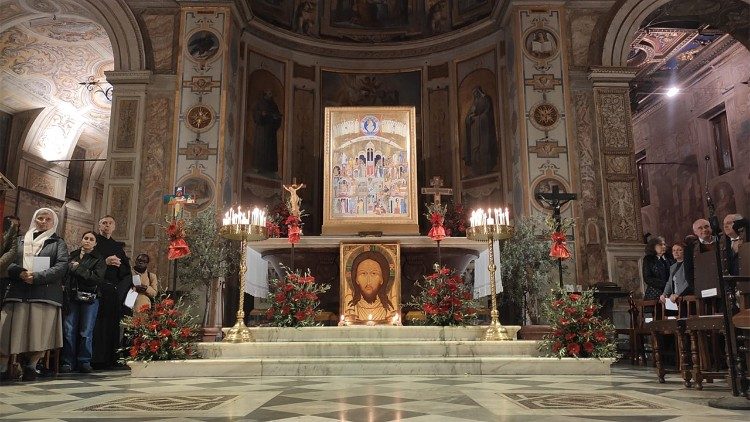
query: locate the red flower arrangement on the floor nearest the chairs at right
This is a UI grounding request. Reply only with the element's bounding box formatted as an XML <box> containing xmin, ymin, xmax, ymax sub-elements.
<box><xmin>539</xmin><ymin>290</ymin><xmax>618</xmax><ymax>358</ymax></box>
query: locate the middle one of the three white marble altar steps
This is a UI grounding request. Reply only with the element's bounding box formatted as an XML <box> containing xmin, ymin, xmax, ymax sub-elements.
<box><xmin>198</xmin><ymin>339</ymin><xmax>539</xmax><ymax>359</ymax></box>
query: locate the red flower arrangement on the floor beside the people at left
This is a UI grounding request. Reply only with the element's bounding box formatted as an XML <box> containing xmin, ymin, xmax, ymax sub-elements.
<box><xmin>121</xmin><ymin>296</ymin><xmax>200</xmax><ymax>363</ymax></box>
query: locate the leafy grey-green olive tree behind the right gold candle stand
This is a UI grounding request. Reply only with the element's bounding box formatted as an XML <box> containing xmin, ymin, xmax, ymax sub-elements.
<box><xmin>500</xmin><ymin>216</ymin><xmax>555</xmax><ymax>323</ymax></box>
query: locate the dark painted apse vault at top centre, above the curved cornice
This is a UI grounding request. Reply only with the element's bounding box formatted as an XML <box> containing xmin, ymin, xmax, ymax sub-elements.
<box><xmin>245</xmin><ymin>0</ymin><xmax>504</xmax><ymax>43</ymax></box>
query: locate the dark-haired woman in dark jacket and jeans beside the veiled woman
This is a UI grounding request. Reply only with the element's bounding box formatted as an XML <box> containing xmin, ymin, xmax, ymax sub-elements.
<box><xmin>60</xmin><ymin>231</ymin><xmax>107</xmax><ymax>373</ymax></box>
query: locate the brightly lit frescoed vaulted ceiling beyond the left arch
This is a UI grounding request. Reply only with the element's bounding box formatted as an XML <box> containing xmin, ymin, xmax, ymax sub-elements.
<box><xmin>0</xmin><ymin>0</ymin><xmax>114</xmax><ymax>150</ymax></box>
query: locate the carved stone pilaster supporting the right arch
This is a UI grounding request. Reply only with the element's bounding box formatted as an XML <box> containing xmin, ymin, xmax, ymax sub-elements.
<box><xmin>589</xmin><ymin>67</ymin><xmax>643</xmax><ymax>291</ymax></box>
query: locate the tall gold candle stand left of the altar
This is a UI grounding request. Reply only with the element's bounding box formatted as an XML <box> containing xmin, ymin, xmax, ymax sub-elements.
<box><xmin>219</xmin><ymin>224</ymin><xmax>268</xmax><ymax>343</ymax></box>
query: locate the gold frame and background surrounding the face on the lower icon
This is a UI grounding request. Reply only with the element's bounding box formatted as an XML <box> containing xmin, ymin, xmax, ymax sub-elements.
<box><xmin>339</xmin><ymin>242</ymin><xmax>401</xmax><ymax>324</ymax></box>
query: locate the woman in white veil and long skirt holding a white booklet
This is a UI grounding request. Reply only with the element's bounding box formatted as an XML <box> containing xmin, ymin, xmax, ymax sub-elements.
<box><xmin>0</xmin><ymin>208</ymin><xmax>68</xmax><ymax>381</ymax></box>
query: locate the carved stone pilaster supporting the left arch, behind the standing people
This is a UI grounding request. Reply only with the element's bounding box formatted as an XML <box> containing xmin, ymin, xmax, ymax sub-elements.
<box><xmin>102</xmin><ymin>70</ymin><xmax>151</xmax><ymax>255</ymax></box>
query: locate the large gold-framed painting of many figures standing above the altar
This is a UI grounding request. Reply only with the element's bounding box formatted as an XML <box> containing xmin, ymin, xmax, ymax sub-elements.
<box><xmin>323</xmin><ymin>107</ymin><xmax>419</xmax><ymax>235</ymax></box>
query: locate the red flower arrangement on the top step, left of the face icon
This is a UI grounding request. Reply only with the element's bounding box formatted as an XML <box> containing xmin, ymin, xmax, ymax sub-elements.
<box><xmin>266</xmin><ymin>271</ymin><xmax>331</xmax><ymax>327</ymax></box>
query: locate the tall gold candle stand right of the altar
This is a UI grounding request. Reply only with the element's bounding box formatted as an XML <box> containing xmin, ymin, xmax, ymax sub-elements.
<box><xmin>466</xmin><ymin>224</ymin><xmax>513</xmax><ymax>341</ymax></box>
